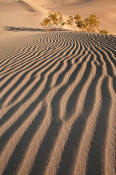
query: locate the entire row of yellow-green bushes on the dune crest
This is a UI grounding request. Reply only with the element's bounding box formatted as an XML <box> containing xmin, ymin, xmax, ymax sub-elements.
<box><xmin>41</xmin><ymin>11</ymin><xmax>108</xmax><ymax>35</ymax></box>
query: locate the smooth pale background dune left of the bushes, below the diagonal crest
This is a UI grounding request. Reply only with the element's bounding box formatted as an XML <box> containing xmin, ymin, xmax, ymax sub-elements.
<box><xmin>0</xmin><ymin>0</ymin><xmax>46</xmax><ymax>33</ymax></box>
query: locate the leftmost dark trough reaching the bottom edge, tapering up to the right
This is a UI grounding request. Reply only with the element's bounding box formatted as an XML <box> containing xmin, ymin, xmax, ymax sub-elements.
<box><xmin>3</xmin><ymin>105</ymin><xmax>46</xmax><ymax>175</ymax></box>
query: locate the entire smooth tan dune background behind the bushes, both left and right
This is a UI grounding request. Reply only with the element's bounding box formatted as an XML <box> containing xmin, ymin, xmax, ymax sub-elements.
<box><xmin>0</xmin><ymin>0</ymin><xmax>116</xmax><ymax>34</ymax></box>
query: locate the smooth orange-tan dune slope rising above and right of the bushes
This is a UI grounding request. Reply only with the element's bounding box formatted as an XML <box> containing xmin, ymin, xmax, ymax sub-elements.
<box><xmin>24</xmin><ymin>0</ymin><xmax>116</xmax><ymax>34</ymax></box>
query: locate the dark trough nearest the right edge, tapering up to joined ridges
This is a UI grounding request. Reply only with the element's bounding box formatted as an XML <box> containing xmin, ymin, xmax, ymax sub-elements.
<box><xmin>86</xmin><ymin>77</ymin><xmax>111</xmax><ymax>175</ymax></box>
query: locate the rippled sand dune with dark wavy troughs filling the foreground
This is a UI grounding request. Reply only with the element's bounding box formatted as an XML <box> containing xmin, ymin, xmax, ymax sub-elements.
<box><xmin>0</xmin><ymin>31</ymin><xmax>116</xmax><ymax>175</ymax></box>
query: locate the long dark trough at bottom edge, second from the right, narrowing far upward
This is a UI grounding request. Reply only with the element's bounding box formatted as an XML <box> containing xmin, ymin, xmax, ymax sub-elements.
<box><xmin>57</xmin><ymin>61</ymin><xmax>102</xmax><ymax>175</ymax></box>
